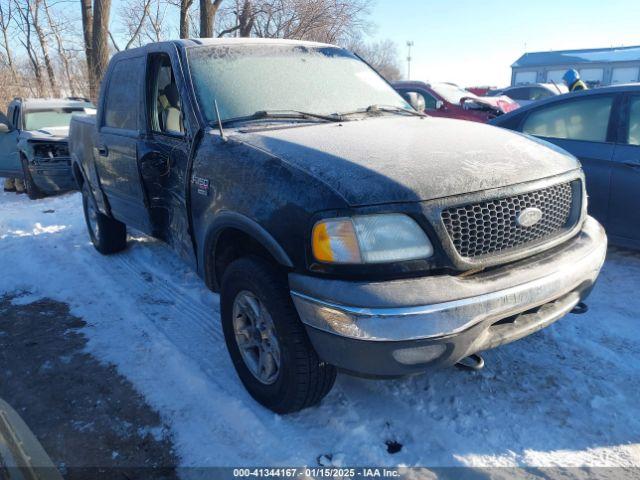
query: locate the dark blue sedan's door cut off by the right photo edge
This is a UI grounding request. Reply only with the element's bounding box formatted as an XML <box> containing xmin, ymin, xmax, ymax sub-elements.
<box><xmin>608</xmin><ymin>94</ymin><xmax>640</xmax><ymax>247</ymax></box>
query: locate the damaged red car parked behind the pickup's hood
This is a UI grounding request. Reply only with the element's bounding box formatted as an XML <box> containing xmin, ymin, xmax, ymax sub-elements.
<box><xmin>392</xmin><ymin>81</ymin><xmax>519</xmax><ymax>123</ymax></box>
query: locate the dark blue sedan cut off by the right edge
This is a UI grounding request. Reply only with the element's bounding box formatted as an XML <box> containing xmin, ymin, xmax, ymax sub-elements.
<box><xmin>489</xmin><ymin>84</ymin><xmax>640</xmax><ymax>249</ymax></box>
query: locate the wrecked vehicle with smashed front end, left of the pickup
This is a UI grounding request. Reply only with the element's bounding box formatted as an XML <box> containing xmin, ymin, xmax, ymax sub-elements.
<box><xmin>0</xmin><ymin>97</ymin><xmax>93</xmax><ymax>199</ymax></box>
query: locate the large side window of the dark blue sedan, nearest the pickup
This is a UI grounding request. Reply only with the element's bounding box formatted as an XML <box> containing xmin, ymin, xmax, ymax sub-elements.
<box><xmin>522</xmin><ymin>96</ymin><xmax>613</xmax><ymax>142</ymax></box>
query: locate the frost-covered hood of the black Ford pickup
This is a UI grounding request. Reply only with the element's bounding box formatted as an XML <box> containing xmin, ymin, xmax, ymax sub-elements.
<box><xmin>232</xmin><ymin>116</ymin><xmax>579</xmax><ymax>206</ymax></box>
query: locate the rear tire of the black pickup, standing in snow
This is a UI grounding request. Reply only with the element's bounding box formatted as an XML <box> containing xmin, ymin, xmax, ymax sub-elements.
<box><xmin>82</xmin><ymin>182</ymin><xmax>127</xmax><ymax>255</ymax></box>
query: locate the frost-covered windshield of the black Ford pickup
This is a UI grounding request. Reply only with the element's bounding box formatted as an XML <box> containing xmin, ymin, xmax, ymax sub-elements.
<box><xmin>188</xmin><ymin>44</ymin><xmax>411</xmax><ymax>122</ymax></box>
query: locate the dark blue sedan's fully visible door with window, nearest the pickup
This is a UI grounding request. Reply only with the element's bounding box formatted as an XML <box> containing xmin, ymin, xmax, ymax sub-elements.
<box><xmin>522</xmin><ymin>94</ymin><xmax>617</xmax><ymax>229</ymax></box>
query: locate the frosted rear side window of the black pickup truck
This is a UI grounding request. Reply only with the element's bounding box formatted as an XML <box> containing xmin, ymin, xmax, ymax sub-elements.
<box><xmin>104</xmin><ymin>58</ymin><xmax>142</xmax><ymax>130</ymax></box>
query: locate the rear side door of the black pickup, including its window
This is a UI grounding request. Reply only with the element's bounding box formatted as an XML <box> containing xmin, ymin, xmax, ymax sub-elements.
<box><xmin>94</xmin><ymin>54</ymin><xmax>153</xmax><ymax>233</ymax></box>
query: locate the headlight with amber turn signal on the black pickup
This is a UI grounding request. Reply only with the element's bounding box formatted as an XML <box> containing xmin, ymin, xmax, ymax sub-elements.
<box><xmin>311</xmin><ymin>213</ymin><xmax>433</xmax><ymax>263</ymax></box>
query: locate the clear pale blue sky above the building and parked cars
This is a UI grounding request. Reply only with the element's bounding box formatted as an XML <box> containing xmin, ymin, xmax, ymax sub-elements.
<box><xmin>371</xmin><ymin>0</ymin><xmax>640</xmax><ymax>87</ymax></box>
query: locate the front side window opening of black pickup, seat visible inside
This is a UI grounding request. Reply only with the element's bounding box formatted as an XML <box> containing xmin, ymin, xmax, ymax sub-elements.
<box><xmin>147</xmin><ymin>54</ymin><xmax>185</xmax><ymax>135</ymax></box>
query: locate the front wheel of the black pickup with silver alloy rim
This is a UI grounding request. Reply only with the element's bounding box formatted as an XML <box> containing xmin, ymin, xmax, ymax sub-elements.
<box><xmin>220</xmin><ymin>257</ymin><xmax>336</xmax><ymax>413</ymax></box>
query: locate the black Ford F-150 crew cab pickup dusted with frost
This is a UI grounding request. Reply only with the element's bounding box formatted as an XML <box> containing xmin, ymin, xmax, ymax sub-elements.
<box><xmin>70</xmin><ymin>39</ymin><xmax>606</xmax><ymax>412</ymax></box>
